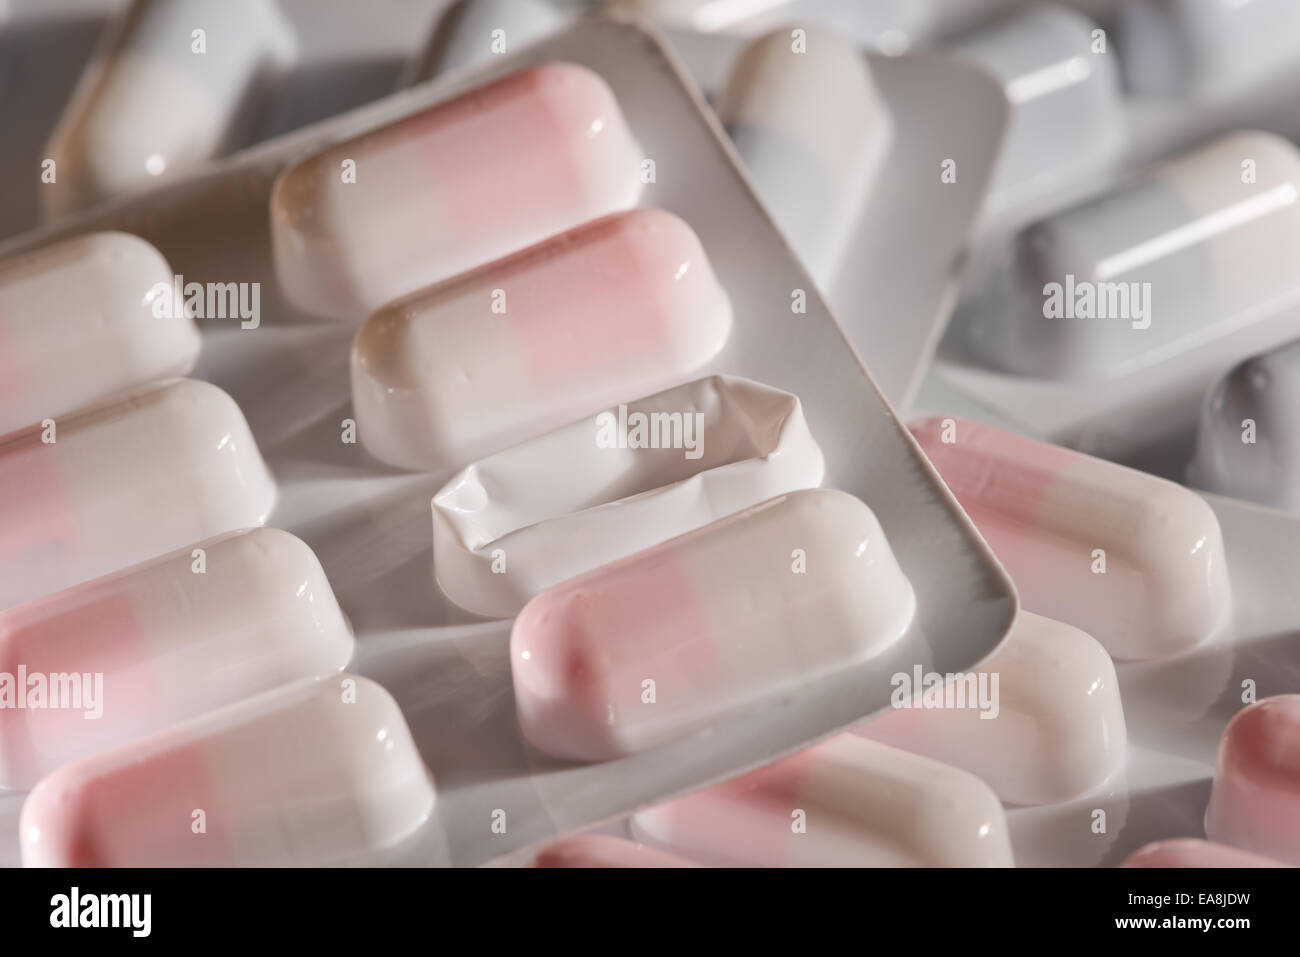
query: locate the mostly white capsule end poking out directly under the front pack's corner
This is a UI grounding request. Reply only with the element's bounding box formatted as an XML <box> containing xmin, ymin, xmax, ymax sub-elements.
<box><xmin>858</xmin><ymin>611</ymin><xmax>1127</xmax><ymax>805</ymax></box>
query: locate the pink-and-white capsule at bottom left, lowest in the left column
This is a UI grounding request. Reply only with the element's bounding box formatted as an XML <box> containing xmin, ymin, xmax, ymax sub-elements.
<box><xmin>18</xmin><ymin>675</ymin><xmax>434</xmax><ymax>867</ymax></box>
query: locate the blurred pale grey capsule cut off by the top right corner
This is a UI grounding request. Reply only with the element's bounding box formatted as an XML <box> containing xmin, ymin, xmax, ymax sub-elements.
<box><xmin>1115</xmin><ymin>0</ymin><xmax>1300</xmax><ymax>96</ymax></box>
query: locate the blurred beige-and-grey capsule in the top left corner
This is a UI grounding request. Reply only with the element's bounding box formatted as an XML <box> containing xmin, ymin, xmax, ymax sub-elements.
<box><xmin>42</xmin><ymin>0</ymin><xmax>298</xmax><ymax>215</ymax></box>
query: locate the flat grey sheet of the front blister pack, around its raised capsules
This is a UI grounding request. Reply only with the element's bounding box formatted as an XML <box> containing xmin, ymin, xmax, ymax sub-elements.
<box><xmin>0</xmin><ymin>21</ymin><xmax>1015</xmax><ymax>865</ymax></box>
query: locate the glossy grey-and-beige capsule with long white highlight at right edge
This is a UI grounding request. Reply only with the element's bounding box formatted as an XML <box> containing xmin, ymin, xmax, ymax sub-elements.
<box><xmin>963</xmin><ymin>133</ymin><xmax>1300</xmax><ymax>378</ymax></box>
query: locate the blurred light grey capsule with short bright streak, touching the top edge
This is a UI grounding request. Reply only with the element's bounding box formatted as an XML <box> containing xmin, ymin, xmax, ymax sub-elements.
<box><xmin>957</xmin><ymin>7</ymin><xmax>1125</xmax><ymax>194</ymax></box>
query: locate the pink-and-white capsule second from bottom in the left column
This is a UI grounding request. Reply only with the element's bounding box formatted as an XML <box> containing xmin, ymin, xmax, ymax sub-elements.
<box><xmin>0</xmin><ymin>528</ymin><xmax>352</xmax><ymax>789</ymax></box>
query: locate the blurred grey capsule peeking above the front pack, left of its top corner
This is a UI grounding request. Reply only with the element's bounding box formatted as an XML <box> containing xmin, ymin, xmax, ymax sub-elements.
<box><xmin>406</xmin><ymin>0</ymin><xmax>568</xmax><ymax>83</ymax></box>
